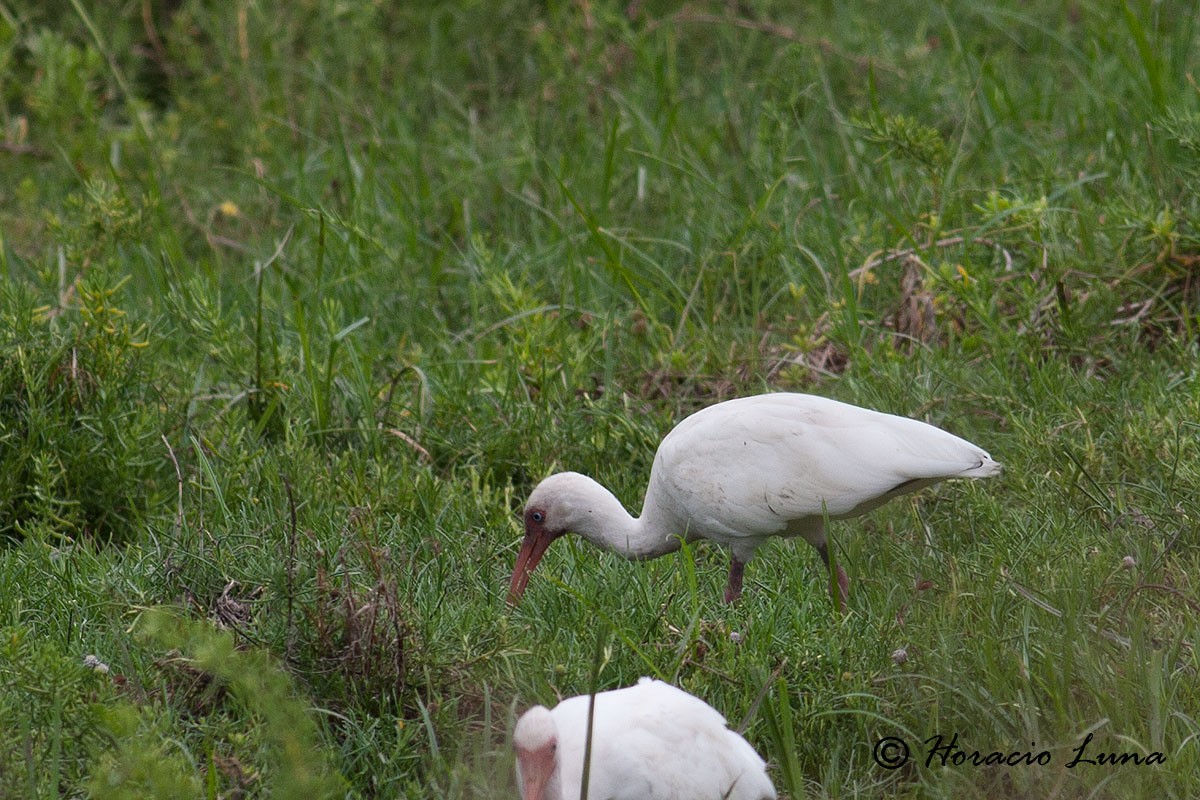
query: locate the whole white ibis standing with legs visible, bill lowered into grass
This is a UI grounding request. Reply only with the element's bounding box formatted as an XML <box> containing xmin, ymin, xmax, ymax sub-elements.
<box><xmin>509</xmin><ymin>392</ymin><xmax>1001</xmax><ymax>603</ymax></box>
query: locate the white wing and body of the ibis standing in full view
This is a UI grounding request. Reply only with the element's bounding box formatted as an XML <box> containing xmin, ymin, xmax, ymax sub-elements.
<box><xmin>652</xmin><ymin>393</ymin><xmax>998</xmax><ymax>539</ymax></box>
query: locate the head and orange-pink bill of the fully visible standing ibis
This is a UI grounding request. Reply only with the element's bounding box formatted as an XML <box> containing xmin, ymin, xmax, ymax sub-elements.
<box><xmin>509</xmin><ymin>473</ymin><xmax>607</xmax><ymax>606</ymax></box>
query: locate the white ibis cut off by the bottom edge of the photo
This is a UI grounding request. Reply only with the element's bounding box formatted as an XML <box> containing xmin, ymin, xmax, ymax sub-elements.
<box><xmin>512</xmin><ymin>678</ymin><xmax>775</xmax><ymax>800</ymax></box>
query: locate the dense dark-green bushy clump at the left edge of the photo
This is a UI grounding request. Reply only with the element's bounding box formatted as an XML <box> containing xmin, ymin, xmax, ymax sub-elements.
<box><xmin>0</xmin><ymin>275</ymin><xmax>163</xmax><ymax>542</ymax></box>
